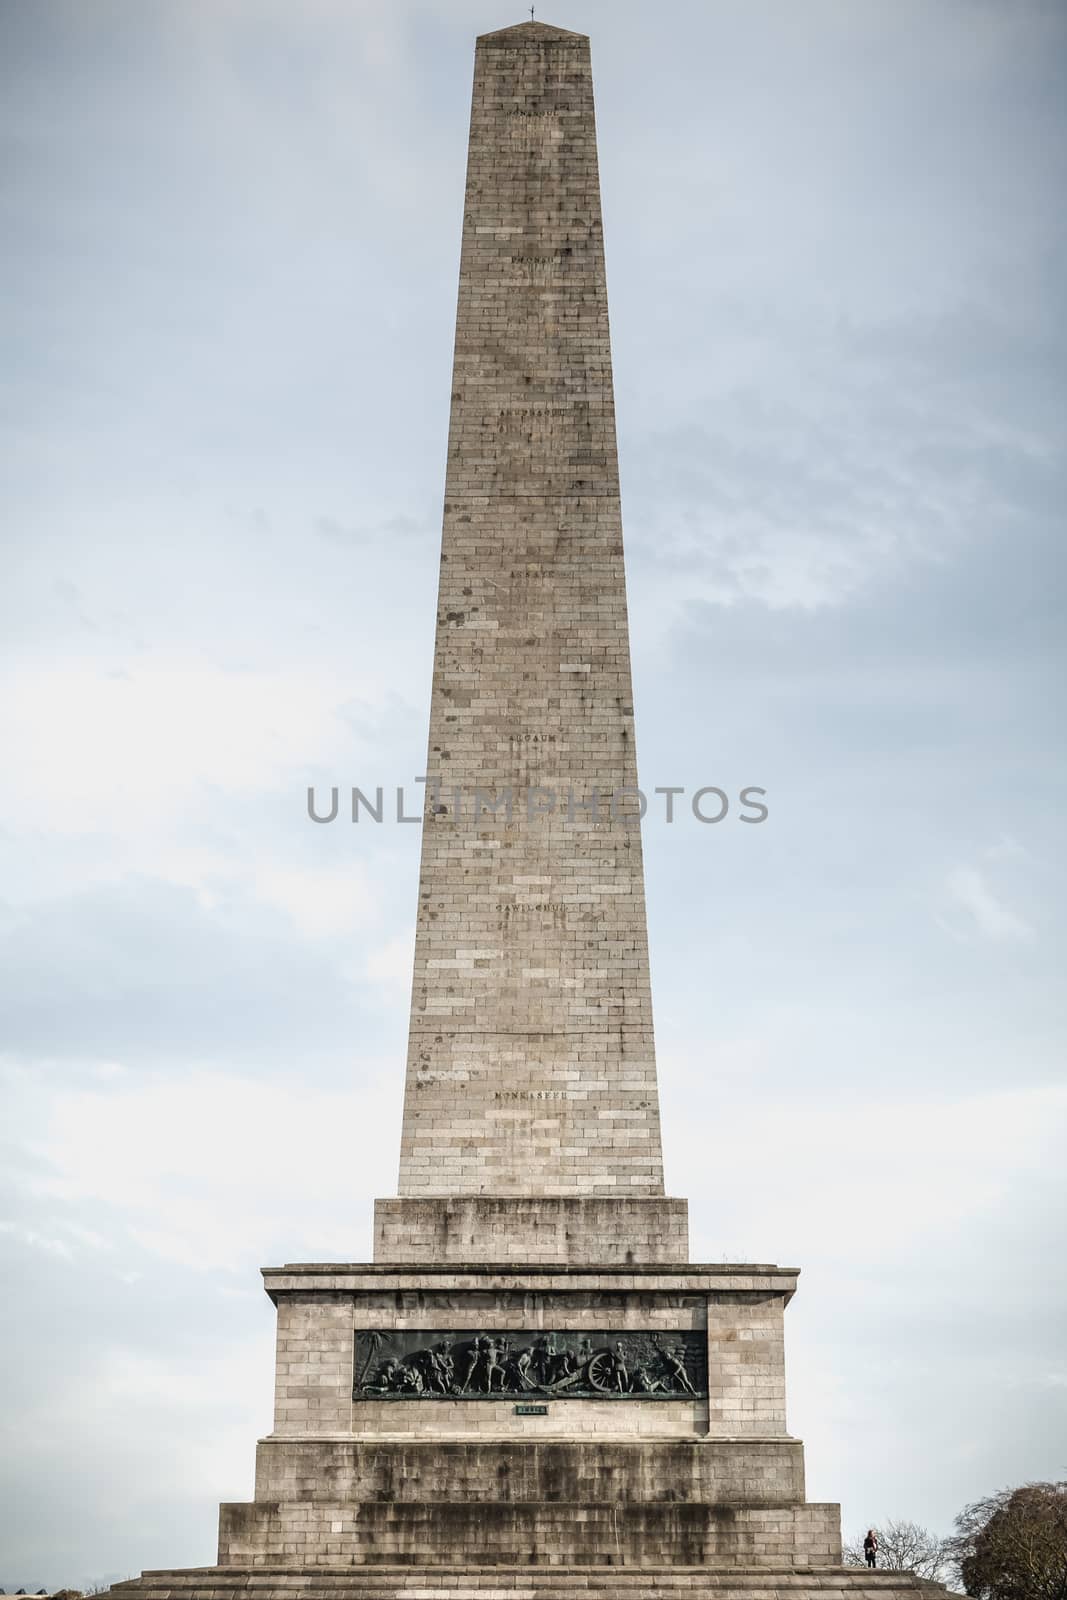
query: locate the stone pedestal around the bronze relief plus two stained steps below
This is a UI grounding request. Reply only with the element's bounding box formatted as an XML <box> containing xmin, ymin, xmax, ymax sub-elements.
<box><xmin>219</xmin><ymin>1262</ymin><xmax>799</xmax><ymax>1570</ymax></box>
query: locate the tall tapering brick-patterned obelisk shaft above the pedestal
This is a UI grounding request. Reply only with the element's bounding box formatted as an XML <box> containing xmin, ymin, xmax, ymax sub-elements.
<box><xmin>400</xmin><ymin>22</ymin><xmax>662</xmax><ymax>1203</ymax></box>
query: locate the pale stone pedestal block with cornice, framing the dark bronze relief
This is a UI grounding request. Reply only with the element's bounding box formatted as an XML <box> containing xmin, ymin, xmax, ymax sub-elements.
<box><xmin>266</xmin><ymin>1266</ymin><xmax>797</xmax><ymax>1440</ymax></box>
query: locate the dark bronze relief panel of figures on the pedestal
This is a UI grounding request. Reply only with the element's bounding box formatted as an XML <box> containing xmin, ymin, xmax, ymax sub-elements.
<box><xmin>352</xmin><ymin>1328</ymin><xmax>707</xmax><ymax>1400</ymax></box>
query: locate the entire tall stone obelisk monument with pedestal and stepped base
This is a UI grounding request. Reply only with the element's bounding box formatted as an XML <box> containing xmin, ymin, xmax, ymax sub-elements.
<box><xmin>106</xmin><ymin>22</ymin><xmax>940</xmax><ymax>1600</ymax></box>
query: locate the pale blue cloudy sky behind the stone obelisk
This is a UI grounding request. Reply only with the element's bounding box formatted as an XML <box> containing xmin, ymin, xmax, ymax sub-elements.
<box><xmin>0</xmin><ymin>0</ymin><xmax>1067</xmax><ymax>1589</ymax></box>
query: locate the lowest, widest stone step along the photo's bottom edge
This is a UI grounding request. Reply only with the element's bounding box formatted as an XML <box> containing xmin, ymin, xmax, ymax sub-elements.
<box><xmin>103</xmin><ymin>1566</ymin><xmax>949</xmax><ymax>1600</ymax></box>
